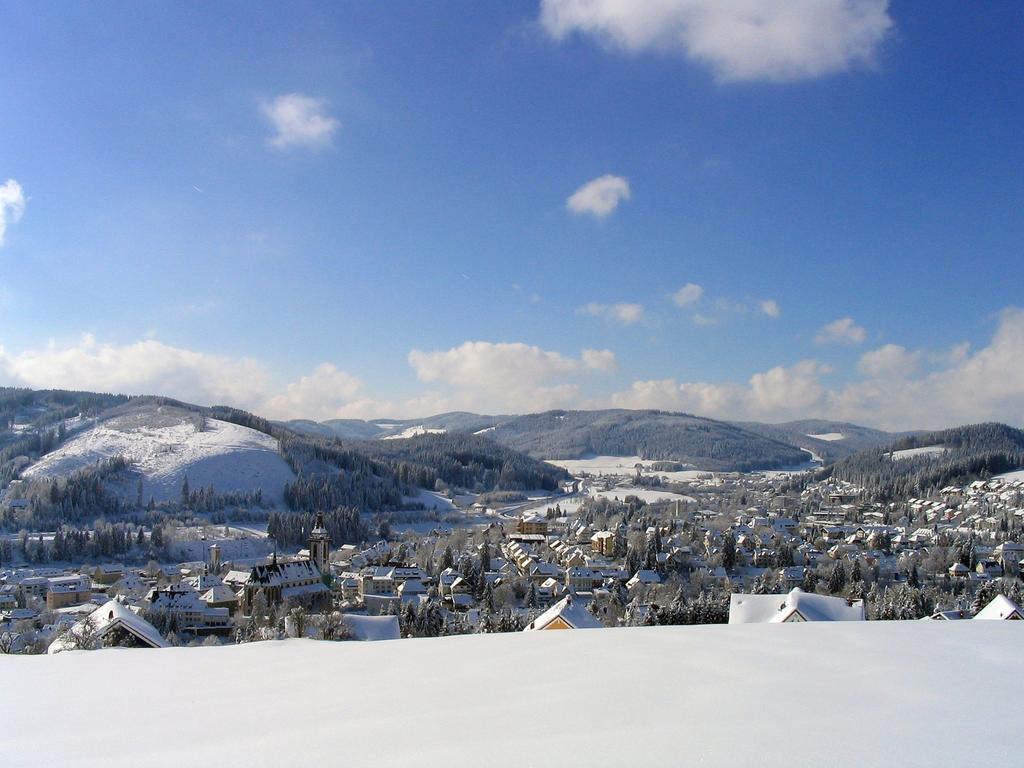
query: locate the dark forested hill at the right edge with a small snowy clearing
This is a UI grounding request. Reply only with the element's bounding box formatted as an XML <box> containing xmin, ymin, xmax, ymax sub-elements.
<box><xmin>821</xmin><ymin>423</ymin><xmax>1024</xmax><ymax>499</ymax></box>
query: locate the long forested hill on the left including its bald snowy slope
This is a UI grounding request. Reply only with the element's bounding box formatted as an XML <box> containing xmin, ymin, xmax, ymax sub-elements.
<box><xmin>0</xmin><ymin>390</ymin><xmax>568</xmax><ymax>529</ymax></box>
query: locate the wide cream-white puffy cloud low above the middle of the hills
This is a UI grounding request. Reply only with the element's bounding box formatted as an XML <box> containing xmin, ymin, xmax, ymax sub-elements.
<box><xmin>409</xmin><ymin>341</ymin><xmax>616</xmax><ymax>413</ymax></box>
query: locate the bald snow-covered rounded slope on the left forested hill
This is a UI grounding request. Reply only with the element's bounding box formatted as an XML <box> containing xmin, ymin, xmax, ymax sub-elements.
<box><xmin>24</xmin><ymin>404</ymin><xmax>295</xmax><ymax>503</ymax></box>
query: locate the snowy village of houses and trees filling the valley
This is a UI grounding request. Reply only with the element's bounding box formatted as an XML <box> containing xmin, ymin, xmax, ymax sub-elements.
<box><xmin>0</xmin><ymin>456</ymin><xmax>1024</xmax><ymax>653</ymax></box>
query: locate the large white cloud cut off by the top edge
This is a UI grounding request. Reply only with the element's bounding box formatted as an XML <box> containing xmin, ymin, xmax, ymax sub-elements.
<box><xmin>540</xmin><ymin>0</ymin><xmax>893</xmax><ymax>82</ymax></box>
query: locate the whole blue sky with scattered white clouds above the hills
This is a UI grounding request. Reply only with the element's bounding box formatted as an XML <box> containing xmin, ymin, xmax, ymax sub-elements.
<box><xmin>0</xmin><ymin>0</ymin><xmax>1024</xmax><ymax>428</ymax></box>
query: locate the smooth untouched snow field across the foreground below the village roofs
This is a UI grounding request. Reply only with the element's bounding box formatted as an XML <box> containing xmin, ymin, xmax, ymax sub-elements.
<box><xmin>0</xmin><ymin>622</ymin><xmax>1024</xmax><ymax>768</ymax></box>
